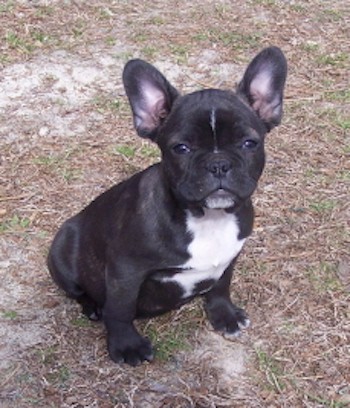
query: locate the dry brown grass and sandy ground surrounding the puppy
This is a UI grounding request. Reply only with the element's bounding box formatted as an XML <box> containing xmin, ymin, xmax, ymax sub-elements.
<box><xmin>0</xmin><ymin>0</ymin><xmax>350</xmax><ymax>408</ymax></box>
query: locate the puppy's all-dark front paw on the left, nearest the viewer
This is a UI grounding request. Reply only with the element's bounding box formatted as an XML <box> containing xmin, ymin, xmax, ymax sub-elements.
<box><xmin>108</xmin><ymin>330</ymin><xmax>154</xmax><ymax>367</ymax></box>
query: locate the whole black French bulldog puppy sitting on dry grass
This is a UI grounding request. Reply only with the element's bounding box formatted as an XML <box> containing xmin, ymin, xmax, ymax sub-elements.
<box><xmin>48</xmin><ymin>47</ymin><xmax>287</xmax><ymax>365</ymax></box>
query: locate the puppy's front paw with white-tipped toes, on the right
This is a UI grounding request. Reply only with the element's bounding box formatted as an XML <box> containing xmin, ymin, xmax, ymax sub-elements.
<box><xmin>205</xmin><ymin>299</ymin><xmax>250</xmax><ymax>337</ymax></box>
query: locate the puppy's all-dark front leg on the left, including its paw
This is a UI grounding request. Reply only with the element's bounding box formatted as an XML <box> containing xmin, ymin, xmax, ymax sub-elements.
<box><xmin>103</xmin><ymin>264</ymin><xmax>153</xmax><ymax>366</ymax></box>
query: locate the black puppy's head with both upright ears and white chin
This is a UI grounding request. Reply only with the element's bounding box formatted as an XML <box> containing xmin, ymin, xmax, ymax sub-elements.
<box><xmin>123</xmin><ymin>47</ymin><xmax>287</xmax><ymax>210</ymax></box>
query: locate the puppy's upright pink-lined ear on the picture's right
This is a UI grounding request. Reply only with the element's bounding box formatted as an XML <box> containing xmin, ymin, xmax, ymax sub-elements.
<box><xmin>237</xmin><ymin>47</ymin><xmax>287</xmax><ymax>131</ymax></box>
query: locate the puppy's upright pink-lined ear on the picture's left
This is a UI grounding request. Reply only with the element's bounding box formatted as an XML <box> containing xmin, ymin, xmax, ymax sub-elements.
<box><xmin>123</xmin><ymin>59</ymin><xmax>179</xmax><ymax>140</ymax></box>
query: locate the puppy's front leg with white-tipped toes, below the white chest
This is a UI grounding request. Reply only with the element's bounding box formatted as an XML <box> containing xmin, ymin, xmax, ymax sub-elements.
<box><xmin>204</xmin><ymin>262</ymin><xmax>250</xmax><ymax>336</ymax></box>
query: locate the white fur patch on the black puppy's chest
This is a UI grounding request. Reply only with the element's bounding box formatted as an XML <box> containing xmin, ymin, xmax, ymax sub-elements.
<box><xmin>165</xmin><ymin>209</ymin><xmax>245</xmax><ymax>298</ymax></box>
